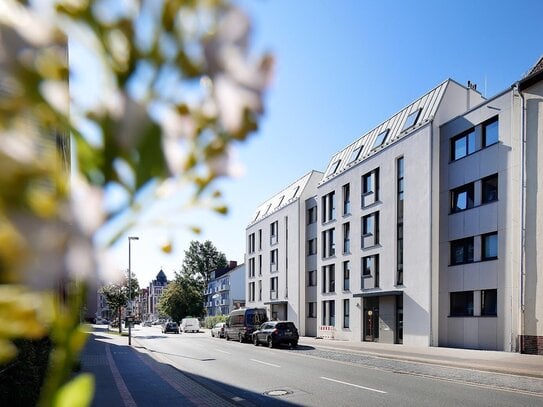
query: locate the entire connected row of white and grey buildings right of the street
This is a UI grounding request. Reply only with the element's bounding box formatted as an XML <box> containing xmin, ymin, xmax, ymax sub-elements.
<box><xmin>246</xmin><ymin>55</ymin><xmax>543</xmax><ymax>354</ymax></box>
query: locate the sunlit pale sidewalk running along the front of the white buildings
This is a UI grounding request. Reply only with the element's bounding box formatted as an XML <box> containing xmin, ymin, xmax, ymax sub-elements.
<box><xmin>299</xmin><ymin>337</ymin><xmax>543</xmax><ymax>378</ymax></box>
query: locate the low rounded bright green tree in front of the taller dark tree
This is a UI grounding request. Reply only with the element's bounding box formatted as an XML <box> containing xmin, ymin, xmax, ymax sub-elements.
<box><xmin>158</xmin><ymin>273</ymin><xmax>204</xmax><ymax>322</ymax></box>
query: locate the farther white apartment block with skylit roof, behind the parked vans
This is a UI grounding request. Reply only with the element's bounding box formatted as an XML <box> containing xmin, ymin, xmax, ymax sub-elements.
<box><xmin>245</xmin><ymin>171</ymin><xmax>322</xmax><ymax>335</ymax></box>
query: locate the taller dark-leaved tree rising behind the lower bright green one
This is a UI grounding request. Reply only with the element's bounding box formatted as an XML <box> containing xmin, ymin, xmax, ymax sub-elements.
<box><xmin>181</xmin><ymin>240</ymin><xmax>228</xmax><ymax>287</ymax></box>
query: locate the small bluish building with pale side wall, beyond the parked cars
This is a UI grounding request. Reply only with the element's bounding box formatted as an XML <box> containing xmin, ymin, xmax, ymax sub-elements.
<box><xmin>204</xmin><ymin>261</ymin><xmax>245</xmax><ymax>316</ymax></box>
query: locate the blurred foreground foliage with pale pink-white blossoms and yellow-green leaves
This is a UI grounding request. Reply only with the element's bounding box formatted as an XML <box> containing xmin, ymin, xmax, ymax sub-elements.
<box><xmin>0</xmin><ymin>0</ymin><xmax>272</xmax><ymax>406</ymax></box>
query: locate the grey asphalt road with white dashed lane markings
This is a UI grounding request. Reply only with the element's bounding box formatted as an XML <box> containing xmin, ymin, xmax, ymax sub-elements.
<box><xmin>133</xmin><ymin>327</ymin><xmax>543</xmax><ymax>407</ymax></box>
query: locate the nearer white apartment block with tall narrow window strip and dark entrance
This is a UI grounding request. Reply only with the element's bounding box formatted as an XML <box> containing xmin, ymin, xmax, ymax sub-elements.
<box><xmin>317</xmin><ymin>80</ymin><xmax>483</xmax><ymax>346</ymax></box>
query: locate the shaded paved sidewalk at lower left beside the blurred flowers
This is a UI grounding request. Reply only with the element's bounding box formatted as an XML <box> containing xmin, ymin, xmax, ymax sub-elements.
<box><xmin>81</xmin><ymin>326</ymin><xmax>233</xmax><ymax>407</ymax></box>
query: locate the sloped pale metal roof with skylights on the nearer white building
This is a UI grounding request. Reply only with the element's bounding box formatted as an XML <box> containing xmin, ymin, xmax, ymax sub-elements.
<box><xmin>319</xmin><ymin>79</ymin><xmax>451</xmax><ymax>185</ymax></box>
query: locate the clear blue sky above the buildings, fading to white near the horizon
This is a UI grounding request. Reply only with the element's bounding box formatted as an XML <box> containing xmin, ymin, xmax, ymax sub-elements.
<box><xmin>115</xmin><ymin>0</ymin><xmax>543</xmax><ymax>285</ymax></box>
